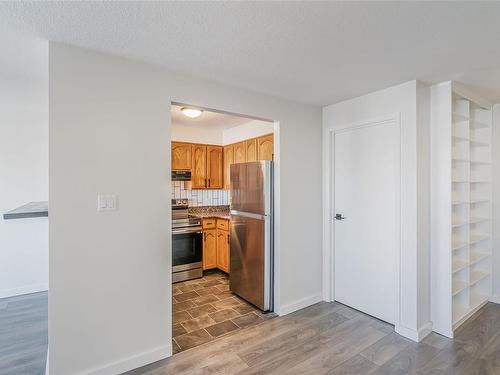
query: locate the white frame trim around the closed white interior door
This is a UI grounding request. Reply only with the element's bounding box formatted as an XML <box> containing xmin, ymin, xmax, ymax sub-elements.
<box><xmin>323</xmin><ymin>113</ymin><xmax>403</xmax><ymax>331</ymax></box>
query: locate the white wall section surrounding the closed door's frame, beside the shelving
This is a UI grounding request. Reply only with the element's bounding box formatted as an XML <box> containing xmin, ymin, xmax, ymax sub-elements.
<box><xmin>323</xmin><ymin>81</ymin><xmax>430</xmax><ymax>340</ymax></box>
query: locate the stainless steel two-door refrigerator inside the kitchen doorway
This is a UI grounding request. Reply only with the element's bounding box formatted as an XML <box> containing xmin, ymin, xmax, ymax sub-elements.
<box><xmin>229</xmin><ymin>161</ymin><xmax>274</xmax><ymax>311</ymax></box>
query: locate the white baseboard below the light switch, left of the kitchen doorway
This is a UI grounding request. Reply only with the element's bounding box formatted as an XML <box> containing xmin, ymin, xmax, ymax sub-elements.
<box><xmin>74</xmin><ymin>344</ymin><xmax>172</xmax><ymax>375</ymax></box>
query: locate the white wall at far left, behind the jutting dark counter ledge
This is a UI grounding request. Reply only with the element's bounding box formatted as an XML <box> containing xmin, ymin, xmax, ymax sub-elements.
<box><xmin>0</xmin><ymin>35</ymin><xmax>48</xmax><ymax>298</ymax></box>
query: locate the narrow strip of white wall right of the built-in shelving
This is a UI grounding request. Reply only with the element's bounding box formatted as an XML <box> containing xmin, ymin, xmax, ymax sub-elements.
<box><xmin>492</xmin><ymin>104</ymin><xmax>500</xmax><ymax>303</ymax></box>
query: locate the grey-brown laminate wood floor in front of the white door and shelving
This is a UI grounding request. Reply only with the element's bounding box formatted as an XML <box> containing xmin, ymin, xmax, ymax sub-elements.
<box><xmin>127</xmin><ymin>302</ymin><xmax>500</xmax><ymax>375</ymax></box>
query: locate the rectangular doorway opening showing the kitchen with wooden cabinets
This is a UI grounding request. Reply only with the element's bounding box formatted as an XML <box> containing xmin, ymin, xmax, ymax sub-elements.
<box><xmin>171</xmin><ymin>103</ymin><xmax>277</xmax><ymax>354</ymax></box>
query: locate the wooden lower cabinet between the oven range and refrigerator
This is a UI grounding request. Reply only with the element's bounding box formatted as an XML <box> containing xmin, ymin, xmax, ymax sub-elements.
<box><xmin>203</xmin><ymin>219</ymin><xmax>230</xmax><ymax>273</ymax></box>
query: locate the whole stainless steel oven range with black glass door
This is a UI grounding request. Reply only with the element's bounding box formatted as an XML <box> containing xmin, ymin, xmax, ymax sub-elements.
<box><xmin>172</xmin><ymin>199</ymin><xmax>203</xmax><ymax>283</ymax></box>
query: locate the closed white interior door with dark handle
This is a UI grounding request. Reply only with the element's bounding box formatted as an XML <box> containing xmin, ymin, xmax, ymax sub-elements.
<box><xmin>332</xmin><ymin>121</ymin><xmax>400</xmax><ymax>324</ymax></box>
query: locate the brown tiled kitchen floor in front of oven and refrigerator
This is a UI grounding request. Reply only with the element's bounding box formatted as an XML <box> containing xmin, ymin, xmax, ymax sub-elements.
<box><xmin>172</xmin><ymin>271</ymin><xmax>275</xmax><ymax>354</ymax></box>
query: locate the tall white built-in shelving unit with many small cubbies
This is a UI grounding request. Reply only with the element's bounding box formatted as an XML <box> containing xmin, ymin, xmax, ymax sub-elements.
<box><xmin>431</xmin><ymin>82</ymin><xmax>492</xmax><ymax>337</ymax></box>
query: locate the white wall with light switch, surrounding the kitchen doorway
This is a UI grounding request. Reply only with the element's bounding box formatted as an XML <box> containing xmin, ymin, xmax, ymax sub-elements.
<box><xmin>49</xmin><ymin>43</ymin><xmax>322</xmax><ymax>375</ymax></box>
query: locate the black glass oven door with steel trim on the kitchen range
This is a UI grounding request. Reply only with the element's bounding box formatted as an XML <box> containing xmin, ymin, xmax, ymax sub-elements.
<box><xmin>172</xmin><ymin>226</ymin><xmax>203</xmax><ymax>272</ymax></box>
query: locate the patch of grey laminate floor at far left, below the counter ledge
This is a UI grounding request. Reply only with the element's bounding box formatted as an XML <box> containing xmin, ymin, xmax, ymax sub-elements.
<box><xmin>0</xmin><ymin>292</ymin><xmax>48</xmax><ymax>375</ymax></box>
